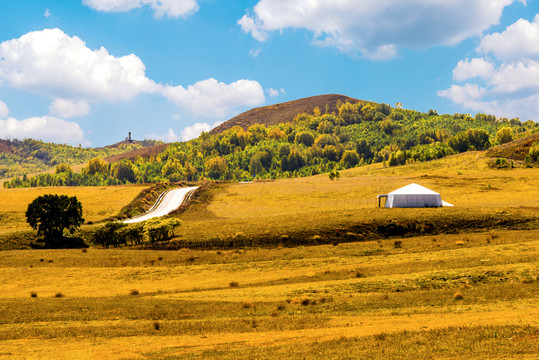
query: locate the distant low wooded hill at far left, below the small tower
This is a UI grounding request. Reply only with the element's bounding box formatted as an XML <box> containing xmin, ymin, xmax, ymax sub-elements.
<box><xmin>0</xmin><ymin>139</ymin><xmax>157</xmax><ymax>178</ymax></box>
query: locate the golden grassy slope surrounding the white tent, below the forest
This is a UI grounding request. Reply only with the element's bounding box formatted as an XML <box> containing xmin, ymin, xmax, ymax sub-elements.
<box><xmin>175</xmin><ymin>152</ymin><xmax>539</xmax><ymax>246</ymax></box>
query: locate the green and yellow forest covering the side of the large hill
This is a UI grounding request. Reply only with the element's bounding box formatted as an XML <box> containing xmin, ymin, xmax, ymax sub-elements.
<box><xmin>4</xmin><ymin>102</ymin><xmax>539</xmax><ymax>187</ymax></box>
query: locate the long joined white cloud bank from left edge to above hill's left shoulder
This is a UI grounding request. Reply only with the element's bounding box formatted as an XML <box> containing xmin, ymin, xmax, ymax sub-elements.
<box><xmin>0</xmin><ymin>29</ymin><xmax>265</xmax><ymax>118</ymax></box>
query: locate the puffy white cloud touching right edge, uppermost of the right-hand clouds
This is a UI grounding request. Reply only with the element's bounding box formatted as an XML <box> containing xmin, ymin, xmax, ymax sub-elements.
<box><xmin>477</xmin><ymin>14</ymin><xmax>539</xmax><ymax>61</ymax></box>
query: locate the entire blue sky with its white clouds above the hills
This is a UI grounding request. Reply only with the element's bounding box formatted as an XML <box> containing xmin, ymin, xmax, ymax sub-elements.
<box><xmin>0</xmin><ymin>0</ymin><xmax>539</xmax><ymax>146</ymax></box>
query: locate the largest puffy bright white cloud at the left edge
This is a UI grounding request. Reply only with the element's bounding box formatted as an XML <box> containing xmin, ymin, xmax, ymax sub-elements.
<box><xmin>0</xmin><ymin>29</ymin><xmax>159</xmax><ymax>101</ymax></box>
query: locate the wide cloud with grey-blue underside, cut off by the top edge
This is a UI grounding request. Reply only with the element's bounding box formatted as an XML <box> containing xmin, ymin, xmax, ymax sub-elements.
<box><xmin>238</xmin><ymin>0</ymin><xmax>524</xmax><ymax>59</ymax></box>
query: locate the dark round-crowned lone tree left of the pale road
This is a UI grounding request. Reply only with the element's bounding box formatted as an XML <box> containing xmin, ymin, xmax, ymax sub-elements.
<box><xmin>26</xmin><ymin>195</ymin><xmax>84</xmax><ymax>248</ymax></box>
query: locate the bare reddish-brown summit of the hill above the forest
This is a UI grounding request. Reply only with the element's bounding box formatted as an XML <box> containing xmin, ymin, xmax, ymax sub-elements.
<box><xmin>210</xmin><ymin>94</ymin><xmax>367</xmax><ymax>135</ymax></box>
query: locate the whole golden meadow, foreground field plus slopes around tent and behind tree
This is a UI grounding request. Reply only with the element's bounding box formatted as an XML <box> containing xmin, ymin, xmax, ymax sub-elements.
<box><xmin>0</xmin><ymin>152</ymin><xmax>539</xmax><ymax>359</ymax></box>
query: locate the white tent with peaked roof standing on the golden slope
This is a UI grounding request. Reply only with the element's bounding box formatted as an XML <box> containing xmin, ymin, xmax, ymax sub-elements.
<box><xmin>378</xmin><ymin>183</ymin><xmax>453</xmax><ymax>207</ymax></box>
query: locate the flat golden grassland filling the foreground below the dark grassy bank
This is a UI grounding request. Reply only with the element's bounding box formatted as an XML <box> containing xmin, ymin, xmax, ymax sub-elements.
<box><xmin>0</xmin><ymin>230</ymin><xmax>539</xmax><ymax>359</ymax></box>
